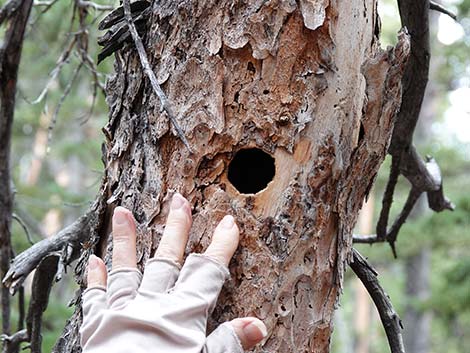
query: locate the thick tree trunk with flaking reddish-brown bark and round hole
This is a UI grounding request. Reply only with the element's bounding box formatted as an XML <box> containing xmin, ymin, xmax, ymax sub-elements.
<box><xmin>58</xmin><ymin>0</ymin><xmax>409</xmax><ymax>353</ymax></box>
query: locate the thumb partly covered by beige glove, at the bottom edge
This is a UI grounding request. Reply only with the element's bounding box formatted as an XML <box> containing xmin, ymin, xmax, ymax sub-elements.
<box><xmin>202</xmin><ymin>317</ymin><xmax>267</xmax><ymax>353</ymax></box>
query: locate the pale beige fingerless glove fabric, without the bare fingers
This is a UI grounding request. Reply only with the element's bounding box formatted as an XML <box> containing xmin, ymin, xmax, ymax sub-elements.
<box><xmin>80</xmin><ymin>254</ymin><xmax>243</xmax><ymax>353</ymax></box>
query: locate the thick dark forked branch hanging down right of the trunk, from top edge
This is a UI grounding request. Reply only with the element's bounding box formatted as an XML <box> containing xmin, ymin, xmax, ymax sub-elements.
<box><xmin>353</xmin><ymin>0</ymin><xmax>454</xmax><ymax>252</ymax></box>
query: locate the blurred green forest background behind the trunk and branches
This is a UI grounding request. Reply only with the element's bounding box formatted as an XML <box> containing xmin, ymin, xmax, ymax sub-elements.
<box><xmin>0</xmin><ymin>0</ymin><xmax>470</xmax><ymax>353</ymax></box>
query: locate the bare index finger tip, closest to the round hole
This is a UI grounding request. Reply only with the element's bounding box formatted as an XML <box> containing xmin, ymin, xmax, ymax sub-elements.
<box><xmin>204</xmin><ymin>215</ymin><xmax>239</xmax><ymax>266</ymax></box>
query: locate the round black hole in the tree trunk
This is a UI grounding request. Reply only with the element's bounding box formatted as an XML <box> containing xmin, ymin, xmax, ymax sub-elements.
<box><xmin>228</xmin><ymin>148</ymin><xmax>276</xmax><ymax>194</ymax></box>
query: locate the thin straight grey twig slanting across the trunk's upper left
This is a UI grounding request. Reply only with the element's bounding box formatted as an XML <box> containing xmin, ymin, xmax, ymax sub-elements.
<box><xmin>123</xmin><ymin>0</ymin><xmax>191</xmax><ymax>151</ymax></box>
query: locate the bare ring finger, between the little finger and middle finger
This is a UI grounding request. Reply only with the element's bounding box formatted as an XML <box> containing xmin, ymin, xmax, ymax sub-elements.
<box><xmin>113</xmin><ymin>206</ymin><xmax>137</xmax><ymax>270</ymax></box>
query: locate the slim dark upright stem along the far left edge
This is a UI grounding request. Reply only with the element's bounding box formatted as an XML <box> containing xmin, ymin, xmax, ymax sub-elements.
<box><xmin>0</xmin><ymin>0</ymin><xmax>33</xmax><ymax>334</ymax></box>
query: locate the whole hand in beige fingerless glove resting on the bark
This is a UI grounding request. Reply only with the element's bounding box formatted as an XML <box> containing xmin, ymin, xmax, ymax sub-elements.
<box><xmin>80</xmin><ymin>194</ymin><xmax>266</xmax><ymax>353</ymax></box>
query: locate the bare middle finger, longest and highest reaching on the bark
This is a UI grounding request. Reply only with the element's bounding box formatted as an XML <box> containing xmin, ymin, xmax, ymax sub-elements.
<box><xmin>155</xmin><ymin>193</ymin><xmax>192</xmax><ymax>264</ymax></box>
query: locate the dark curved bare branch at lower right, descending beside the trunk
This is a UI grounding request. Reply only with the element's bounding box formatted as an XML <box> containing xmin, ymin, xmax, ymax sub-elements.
<box><xmin>349</xmin><ymin>249</ymin><xmax>405</xmax><ymax>353</ymax></box>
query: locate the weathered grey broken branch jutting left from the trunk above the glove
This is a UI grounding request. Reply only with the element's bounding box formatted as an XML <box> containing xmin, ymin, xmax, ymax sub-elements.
<box><xmin>3</xmin><ymin>211</ymin><xmax>92</xmax><ymax>294</ymax></box>
